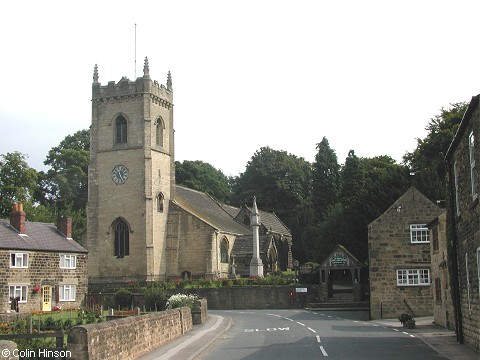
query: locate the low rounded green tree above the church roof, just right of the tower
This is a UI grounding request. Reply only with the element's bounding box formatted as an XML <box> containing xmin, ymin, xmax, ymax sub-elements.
<box><xmin>175</xmin><ymin>160</ymin><xmax>230</xmax><ymax>202</ymax></box>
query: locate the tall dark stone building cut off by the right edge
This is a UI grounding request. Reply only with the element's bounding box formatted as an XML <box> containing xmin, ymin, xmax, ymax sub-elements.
<box><xmin>446</xmin><ymin>95</ymin><xmax>480</xmax><ymax>351</ymax></box>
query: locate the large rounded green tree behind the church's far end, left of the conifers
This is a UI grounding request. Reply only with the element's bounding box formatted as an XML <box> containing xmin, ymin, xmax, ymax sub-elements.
<box><xmin>231</xmin><ymin>147</ymin><xmax>312</xmax><ymax>256</ymax></box>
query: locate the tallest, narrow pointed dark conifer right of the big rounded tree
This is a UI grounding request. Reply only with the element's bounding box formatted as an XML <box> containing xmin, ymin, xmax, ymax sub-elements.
<box><xmin>312</xmin><ymin>137</ymin><xmax>340</xmax><ymax>221</ymax></box>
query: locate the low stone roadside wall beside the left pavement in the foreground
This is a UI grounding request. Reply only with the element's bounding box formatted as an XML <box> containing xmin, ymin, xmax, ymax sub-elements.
<box><xmin>67</xmin><ymin>307</ymin><xmax>193</xmax><ymax>360</ymax></box>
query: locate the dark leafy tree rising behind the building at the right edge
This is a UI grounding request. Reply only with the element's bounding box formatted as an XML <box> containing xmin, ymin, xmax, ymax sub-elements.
<box><xmin>403</xmin><ymin>102</ymin><xmax>468</xmax><ymax>201</ymax></box>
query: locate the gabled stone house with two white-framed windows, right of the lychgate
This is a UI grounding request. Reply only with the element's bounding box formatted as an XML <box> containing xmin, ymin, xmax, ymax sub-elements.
<box><xmin>368</xmin><ymin>186</ymin><xmax>442</xmax><ymax>319</ymax></box>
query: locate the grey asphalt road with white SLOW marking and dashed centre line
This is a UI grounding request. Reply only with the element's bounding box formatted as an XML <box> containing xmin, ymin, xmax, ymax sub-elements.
<box><xmin>200</xmin><ymin>310</ymin><xmax>445</xmax><ymax>360</ymax></box>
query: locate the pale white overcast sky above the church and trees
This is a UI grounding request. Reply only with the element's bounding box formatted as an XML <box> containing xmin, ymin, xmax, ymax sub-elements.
<box><xmin>0</xmin><ymin>0</ymin><xmax>480</xmax><ymax>176</ymax></box>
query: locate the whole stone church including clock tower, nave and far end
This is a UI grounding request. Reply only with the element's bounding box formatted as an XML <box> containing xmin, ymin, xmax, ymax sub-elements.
<box><xmin>86</xmin><ymin>58</ymin><xmax>292</xmax><ymax>284</ymax></box>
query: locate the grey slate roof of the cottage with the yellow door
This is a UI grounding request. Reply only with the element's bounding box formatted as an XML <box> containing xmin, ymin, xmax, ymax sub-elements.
<box><xmin>0</xmin><ymin>220</ymin><xmax>88</xmax><ymax>253</ymax></box>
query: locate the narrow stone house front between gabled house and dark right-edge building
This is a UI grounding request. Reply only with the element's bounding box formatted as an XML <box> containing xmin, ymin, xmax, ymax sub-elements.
<box><xmin>428</xmin><ymin>212</ymin><xmax>455</xmax><ymax>329</ymax></box>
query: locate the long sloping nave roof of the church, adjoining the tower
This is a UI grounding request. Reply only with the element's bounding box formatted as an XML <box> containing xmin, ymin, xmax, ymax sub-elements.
<box><xmin>173</xmin><ymin>185</ymin><xmax>252</xmax><ymax>235</ymax></box>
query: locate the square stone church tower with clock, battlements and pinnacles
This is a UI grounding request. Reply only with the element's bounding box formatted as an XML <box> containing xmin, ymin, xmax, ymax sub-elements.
<box><xmin>87</xmin><ymin>58</ymin><xmax>175</xmax><ymax>284</ymax></box>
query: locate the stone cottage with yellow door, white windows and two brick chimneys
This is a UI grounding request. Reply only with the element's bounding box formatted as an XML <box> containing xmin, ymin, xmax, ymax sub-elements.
<box><xmin>0</xmin><ymin>204</ymin><xmax>88</xmax><ymax>312</ymax></box>
